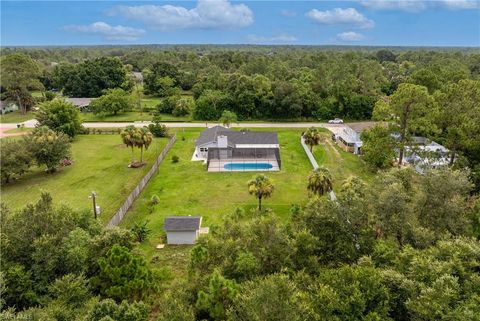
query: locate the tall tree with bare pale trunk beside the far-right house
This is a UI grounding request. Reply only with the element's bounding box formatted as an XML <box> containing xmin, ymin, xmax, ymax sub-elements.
<box><xmin>374</xmin><ymin>83</ymin><xmax>437</xmax><ymax>165</ymax></box>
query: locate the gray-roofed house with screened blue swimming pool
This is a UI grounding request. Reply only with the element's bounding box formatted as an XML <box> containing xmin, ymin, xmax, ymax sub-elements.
<box><xmin>192</xmin><ymin>126</ymin><xmax>281</xmax><ymax>172</ymax></box>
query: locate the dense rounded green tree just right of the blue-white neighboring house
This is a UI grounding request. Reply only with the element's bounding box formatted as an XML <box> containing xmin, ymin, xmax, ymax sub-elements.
<box><xmin>362</xmin><ymin>125</ymin><xmax>395</xmax><ymax>169</ymax></box>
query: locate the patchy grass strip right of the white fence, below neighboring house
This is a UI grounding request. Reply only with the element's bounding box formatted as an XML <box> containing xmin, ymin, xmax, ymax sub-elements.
<box><xmin>313</xmin><ymin>132</ymin><xmax>375</xmax><ymax>191</ymax></box>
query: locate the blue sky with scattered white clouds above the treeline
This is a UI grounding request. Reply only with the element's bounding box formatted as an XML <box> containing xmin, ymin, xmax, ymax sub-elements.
<box><xmin>0</xmin><ymin>0</ymin><xmax>480</xmax><ymax>47</ymax></box>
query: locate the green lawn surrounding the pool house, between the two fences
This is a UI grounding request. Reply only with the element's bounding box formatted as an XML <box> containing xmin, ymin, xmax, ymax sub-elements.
<box><xmin>122</xmin><ymin>129</ymin><xmax>311</xmax><ymax>253</ymax></box>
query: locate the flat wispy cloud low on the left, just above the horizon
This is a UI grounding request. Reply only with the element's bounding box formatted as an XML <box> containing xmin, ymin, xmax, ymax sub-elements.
<box><xmin>63</xmin><ymin>21</ymin><xmax>145</xmax><ymax>41</ymax></box>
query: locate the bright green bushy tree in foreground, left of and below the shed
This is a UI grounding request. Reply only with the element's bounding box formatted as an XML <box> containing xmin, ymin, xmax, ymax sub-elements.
<box><xmin>92</xmin><ymin>244</ymin><xmax>154</xmax><ymax>302</ymax></box>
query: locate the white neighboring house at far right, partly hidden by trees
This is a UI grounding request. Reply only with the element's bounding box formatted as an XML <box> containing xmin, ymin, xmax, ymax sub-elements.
<box><xmin>403</xmin><ymin>136</ymin><xmax>450</xmax><ymax>174</ymax></box>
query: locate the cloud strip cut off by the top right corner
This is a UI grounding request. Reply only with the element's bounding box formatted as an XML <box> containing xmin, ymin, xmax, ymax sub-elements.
<box><xmin>359</xmin><ymin>0</ymin><xmax>480</xmax><ymax>12</ymax></box>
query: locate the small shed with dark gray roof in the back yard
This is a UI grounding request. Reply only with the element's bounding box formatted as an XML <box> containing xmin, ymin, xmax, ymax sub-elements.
<box><xmin>163</xmin><ymin>216</ymin><xmax>202</xmax><ymax>244</ymax></box>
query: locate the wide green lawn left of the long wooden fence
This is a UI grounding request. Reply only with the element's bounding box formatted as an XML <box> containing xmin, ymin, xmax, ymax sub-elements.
<box><xmin>1</xmin><ymin>135</ymin><xmax>167</xmax><ymax>222</ymax></box>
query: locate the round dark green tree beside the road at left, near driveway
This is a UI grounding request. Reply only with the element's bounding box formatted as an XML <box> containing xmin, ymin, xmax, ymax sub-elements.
<box><xmin>36</xmin><ymin>99</ymin><xmax>82</xmax><ymax>138</ymax></box>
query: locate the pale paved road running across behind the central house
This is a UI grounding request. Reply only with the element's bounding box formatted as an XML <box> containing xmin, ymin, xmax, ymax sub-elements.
<box><xmin>12</xmin><ymin>119</ymin><xmax>343</xmax><ymax>131</ymax></box>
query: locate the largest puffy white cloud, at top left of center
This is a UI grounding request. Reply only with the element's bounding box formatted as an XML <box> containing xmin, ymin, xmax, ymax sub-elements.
<box><xmin>109</xmin><ymin>0</ymin><xmax>253</xmax><ymax>30</ymax></box>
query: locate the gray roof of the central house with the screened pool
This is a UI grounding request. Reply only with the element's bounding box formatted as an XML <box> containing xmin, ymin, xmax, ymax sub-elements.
<box><xmin>196</xmin><ymin>126</ymin><xmax>278</xmax><ymax>146</ymax></box>
